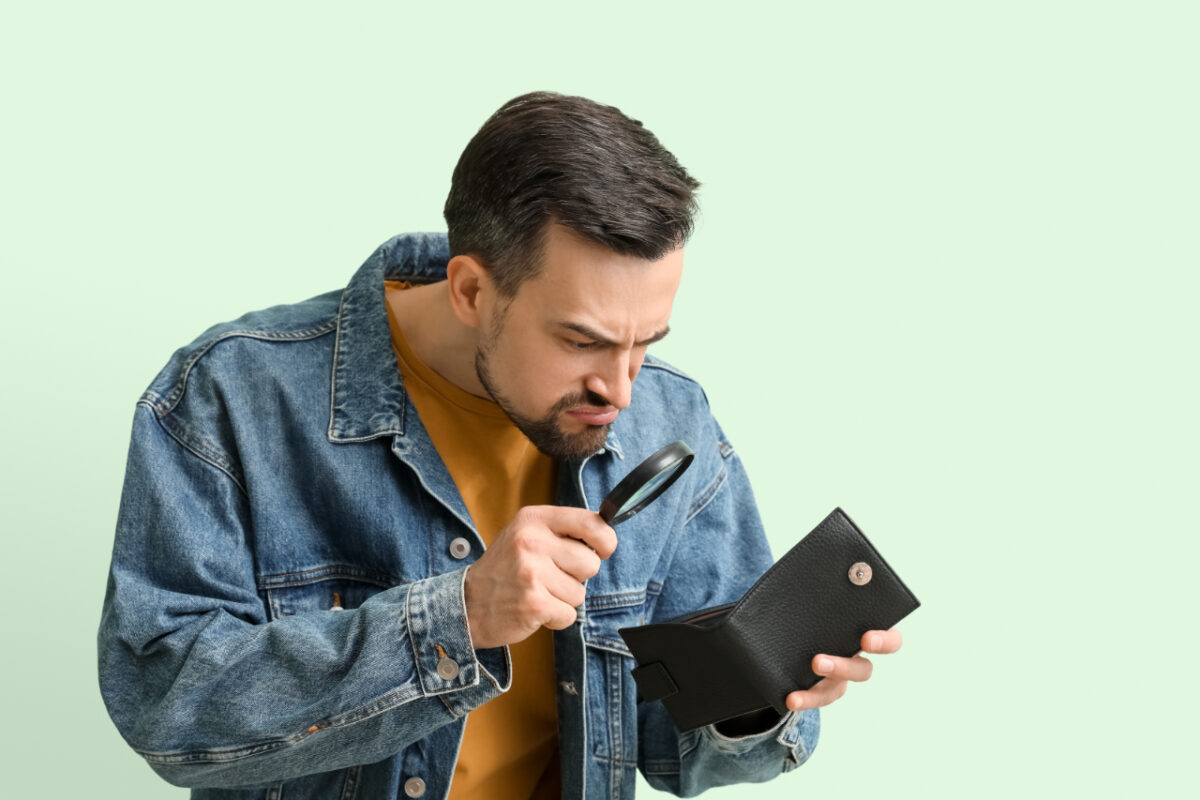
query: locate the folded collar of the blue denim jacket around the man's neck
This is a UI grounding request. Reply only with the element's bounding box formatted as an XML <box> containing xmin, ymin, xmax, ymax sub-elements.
<box><xmin>328</xmin><ymin>227</ymin><xmax>624</xmax><ymax>458</ymax></box>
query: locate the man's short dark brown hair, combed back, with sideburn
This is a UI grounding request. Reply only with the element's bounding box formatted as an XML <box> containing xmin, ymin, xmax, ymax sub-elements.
<box><xmin>444</xmin><ymin>91</ymin><xmax>700</xmax><ymax>297</ymax></box>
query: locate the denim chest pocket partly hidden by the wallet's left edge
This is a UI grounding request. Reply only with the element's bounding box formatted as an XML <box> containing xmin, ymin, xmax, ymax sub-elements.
<box><xmin>583</xmin><ymin>594</ymin><xmax>646</xmax><ymax>766</ymax></box>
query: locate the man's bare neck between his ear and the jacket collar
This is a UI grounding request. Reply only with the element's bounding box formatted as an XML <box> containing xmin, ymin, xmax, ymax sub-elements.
<box><xmin>388</xmin><ymin>281</ymin><xmax>487</xmax><ymax>397</ymax></box>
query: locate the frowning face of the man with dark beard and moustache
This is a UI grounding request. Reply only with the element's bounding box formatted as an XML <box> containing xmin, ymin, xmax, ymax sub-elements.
<box><xmin>475</xmin><ymin>224</ymin><xmax>683</xmax><ymax>459</ymax></box>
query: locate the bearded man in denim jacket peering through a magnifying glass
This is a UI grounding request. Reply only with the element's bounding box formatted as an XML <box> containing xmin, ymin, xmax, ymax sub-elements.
<box><xmin>100</xmin><ymin>94</ymin><xmax>899</xmax><ymax>800</ymax></box>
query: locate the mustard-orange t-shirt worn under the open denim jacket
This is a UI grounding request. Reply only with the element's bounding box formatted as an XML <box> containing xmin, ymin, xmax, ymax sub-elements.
<box><xmin>384</xmin><ymin>281</ymin><xmax>562</xmax><ymax>800</ymax></box>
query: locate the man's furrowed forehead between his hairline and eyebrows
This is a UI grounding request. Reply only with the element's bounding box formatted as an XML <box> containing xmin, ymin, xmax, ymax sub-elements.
<box><xmin>516</xmin><ymin>224</ymin><xmax>683</xmax><ymax>328</ymax></box>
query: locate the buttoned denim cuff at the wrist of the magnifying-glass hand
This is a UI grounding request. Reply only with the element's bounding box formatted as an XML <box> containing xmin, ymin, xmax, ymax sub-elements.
<box><xmin>406</xmin><ymin>569</ymin><xmax>512</xmax><ymax>716</ymax></box>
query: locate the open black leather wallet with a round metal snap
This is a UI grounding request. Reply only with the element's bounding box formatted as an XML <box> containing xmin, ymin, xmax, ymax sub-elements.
<box><xmin>619</xmin><ymin>509</ymin><xmax>920</xmax><ymax>730</ymax></box>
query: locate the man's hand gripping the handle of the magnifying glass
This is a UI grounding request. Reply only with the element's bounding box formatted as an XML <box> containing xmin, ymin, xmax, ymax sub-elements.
<box><xmin>466</xmin><ymin>506</ymin><xmax>617</xmax><ymax>649</ymax></box>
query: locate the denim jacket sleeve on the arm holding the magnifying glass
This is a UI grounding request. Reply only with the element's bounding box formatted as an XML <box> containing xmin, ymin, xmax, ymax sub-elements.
<box><xmin>98</xmin><ymin>404</ymin><xmax>510</xmax><ymax>788</ymax></box>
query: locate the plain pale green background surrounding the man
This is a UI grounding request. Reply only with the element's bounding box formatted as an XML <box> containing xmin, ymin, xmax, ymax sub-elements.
<box><xmin>0</xmin><ymin>1</ymin><xmax>1200</xmax><ymax>798</ymax></box>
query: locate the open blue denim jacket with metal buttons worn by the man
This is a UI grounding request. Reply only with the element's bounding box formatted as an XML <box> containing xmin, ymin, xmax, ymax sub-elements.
<box><xmin>98</xmin><ymin>234</ymin><xmax>820</xmax><ymax>800</ymax></box>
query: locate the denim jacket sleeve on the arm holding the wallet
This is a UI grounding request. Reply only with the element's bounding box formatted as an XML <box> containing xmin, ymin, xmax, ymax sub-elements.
<box><xmin>638</xmin><ymin>428</ymin><xmax>821</xmax><ymax>798</ymax></box>
